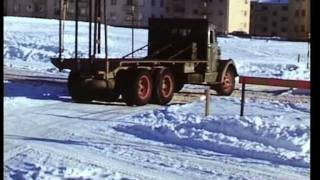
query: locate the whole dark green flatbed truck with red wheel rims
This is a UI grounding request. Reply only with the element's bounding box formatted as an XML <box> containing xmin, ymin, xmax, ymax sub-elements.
<box><xmin>52</xmin><ymin>18</ymin><xmax>238</xmax><ymax>106</ymax></box>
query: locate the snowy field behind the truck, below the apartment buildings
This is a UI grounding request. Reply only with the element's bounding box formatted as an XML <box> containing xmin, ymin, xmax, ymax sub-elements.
<box><xmin>4</xmin><ymin>17</ymin><xmax>310</xmax><ymax>80</ymax></box>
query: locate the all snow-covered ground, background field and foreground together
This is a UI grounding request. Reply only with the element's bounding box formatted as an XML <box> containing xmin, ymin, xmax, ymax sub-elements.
<box><xmin>4</xmin><ymin>17</ymin><xmax>310</xmax><ymax>180</ymax></box>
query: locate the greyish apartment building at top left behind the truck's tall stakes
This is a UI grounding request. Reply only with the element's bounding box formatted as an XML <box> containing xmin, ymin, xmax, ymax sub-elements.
<box><xmin>4</xmin><ymin>0</ymin><xmax>165</xmax><ymax>27</ymax></box>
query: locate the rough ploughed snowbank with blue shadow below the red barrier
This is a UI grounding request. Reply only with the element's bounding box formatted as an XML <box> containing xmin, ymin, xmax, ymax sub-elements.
<box><xmin>116</xmin><ymin>98</ymin><xmax>310</xmax><ymax>167</ymax></box>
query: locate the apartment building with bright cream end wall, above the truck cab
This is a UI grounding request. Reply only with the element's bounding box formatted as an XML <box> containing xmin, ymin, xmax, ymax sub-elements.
<box><xmin>165</xmin><ymin>0</ymin><xmax>250</xmax><ymax>33</ymax></box>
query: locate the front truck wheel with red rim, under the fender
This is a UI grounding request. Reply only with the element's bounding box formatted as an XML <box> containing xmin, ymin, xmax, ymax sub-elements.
<box><xmin>213</xmin><ymin>68</ymin><xmax>235</xmax><ymax>96</ymax></box>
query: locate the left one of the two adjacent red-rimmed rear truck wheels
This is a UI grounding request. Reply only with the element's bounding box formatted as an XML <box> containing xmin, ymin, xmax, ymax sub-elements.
<box><xmin>123</xmin><ymin>69</ymin><xmax>152</xmax><ymax>106</ymax></box>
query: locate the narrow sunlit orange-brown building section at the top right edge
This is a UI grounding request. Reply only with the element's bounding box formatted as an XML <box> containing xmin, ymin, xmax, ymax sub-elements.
<box><xmin>288</xmin><ymin>0</ymin><xmax>310</xmax><ymax>40</ymax></box>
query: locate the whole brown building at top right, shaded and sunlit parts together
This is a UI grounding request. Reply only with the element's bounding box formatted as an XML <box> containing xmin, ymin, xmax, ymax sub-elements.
<box><xmin>250</xmin><ymin>0</ymin><xmax>310</xmax><ymax>40</ymax></box>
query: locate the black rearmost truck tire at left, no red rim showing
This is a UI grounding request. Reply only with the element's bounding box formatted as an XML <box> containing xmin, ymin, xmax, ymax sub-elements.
<box><xmin>68</xmin><ymin>71</ymin><xmax>93</xmax><ymax>103</ymax></box>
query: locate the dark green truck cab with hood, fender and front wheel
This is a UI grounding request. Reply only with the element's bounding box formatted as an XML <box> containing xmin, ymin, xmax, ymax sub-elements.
<box><xmin>147</xmin><ymin>19</ymin><xmax>238</xmax><ymax>95</ymax></box>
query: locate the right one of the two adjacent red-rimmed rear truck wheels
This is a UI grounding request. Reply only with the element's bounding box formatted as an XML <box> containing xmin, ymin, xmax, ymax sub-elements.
<box><xmin>152</xmin><ymin>68</ymin><xmax>175</xmax><ymax>105</ymax></box>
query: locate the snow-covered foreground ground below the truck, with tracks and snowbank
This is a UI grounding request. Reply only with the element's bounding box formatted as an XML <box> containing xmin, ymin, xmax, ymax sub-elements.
<box><xmin>4</xmin><ymin>71</ymin><xmax>309</xmax><ymax>179</ymax></box>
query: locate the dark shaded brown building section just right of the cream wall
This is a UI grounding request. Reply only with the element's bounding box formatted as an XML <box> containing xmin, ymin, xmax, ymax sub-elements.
<box><xmin>250</xmin><ymin>2</ymin><xmax>289</xmax><ymax>37</ymax></box>
